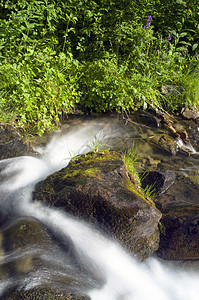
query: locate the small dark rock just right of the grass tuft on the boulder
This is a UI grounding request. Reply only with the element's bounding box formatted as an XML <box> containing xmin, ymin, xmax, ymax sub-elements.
<box><xmin>141</xmin><ymin>170</ymin><xmax>175</xmax><ymax>195</ymax></box>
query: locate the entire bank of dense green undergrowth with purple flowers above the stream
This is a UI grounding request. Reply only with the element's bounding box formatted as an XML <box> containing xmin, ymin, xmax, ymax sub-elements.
<box><xmin>0</xmin><ymin>0</ymin><xmax>199</xmax><ymax>134</ymax></box>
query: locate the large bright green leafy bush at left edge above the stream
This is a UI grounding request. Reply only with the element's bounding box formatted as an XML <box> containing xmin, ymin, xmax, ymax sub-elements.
<box><xmin>0</xmin><ymin>48</ymin><xmax>80</xmax><ymax>134</ymax></box>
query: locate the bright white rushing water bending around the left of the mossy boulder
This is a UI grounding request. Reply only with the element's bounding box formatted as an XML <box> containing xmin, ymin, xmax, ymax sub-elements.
<box><xmin>0</xmin><ymin>123</ymin><xmax>199</xmax><ymax>300</ymax></box>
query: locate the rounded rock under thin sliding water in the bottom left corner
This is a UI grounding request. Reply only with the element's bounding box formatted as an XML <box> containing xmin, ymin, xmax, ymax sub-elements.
<box><xmin>0</xmin><ymin>219</ymin><xmax>101</xmax><ymax>300</ymax></box>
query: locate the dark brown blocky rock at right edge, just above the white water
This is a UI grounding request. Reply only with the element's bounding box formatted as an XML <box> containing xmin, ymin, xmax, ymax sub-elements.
<box><xmin>157</xmin><ymin>205</ymin><xmax>199</xmax><ymax>260</ymax></box>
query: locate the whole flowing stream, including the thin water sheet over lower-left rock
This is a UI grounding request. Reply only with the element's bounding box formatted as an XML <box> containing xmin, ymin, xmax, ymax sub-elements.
<box><xmin>0</xmin><ymin>116</ymin><xmax>199</xmax><ymax>300</ymax></box>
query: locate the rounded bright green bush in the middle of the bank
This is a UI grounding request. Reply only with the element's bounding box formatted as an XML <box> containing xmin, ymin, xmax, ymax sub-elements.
<box><xmin>81</xmin><ymin>58</ymin><xmax>138</xmax><ymax>112</ymax></box>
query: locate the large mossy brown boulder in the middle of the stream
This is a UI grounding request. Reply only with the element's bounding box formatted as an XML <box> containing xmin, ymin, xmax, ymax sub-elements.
<box><xmin>33</xmin><ymin>152</ymin><xmax>161</xmax><ymax>259</ymax></box>
